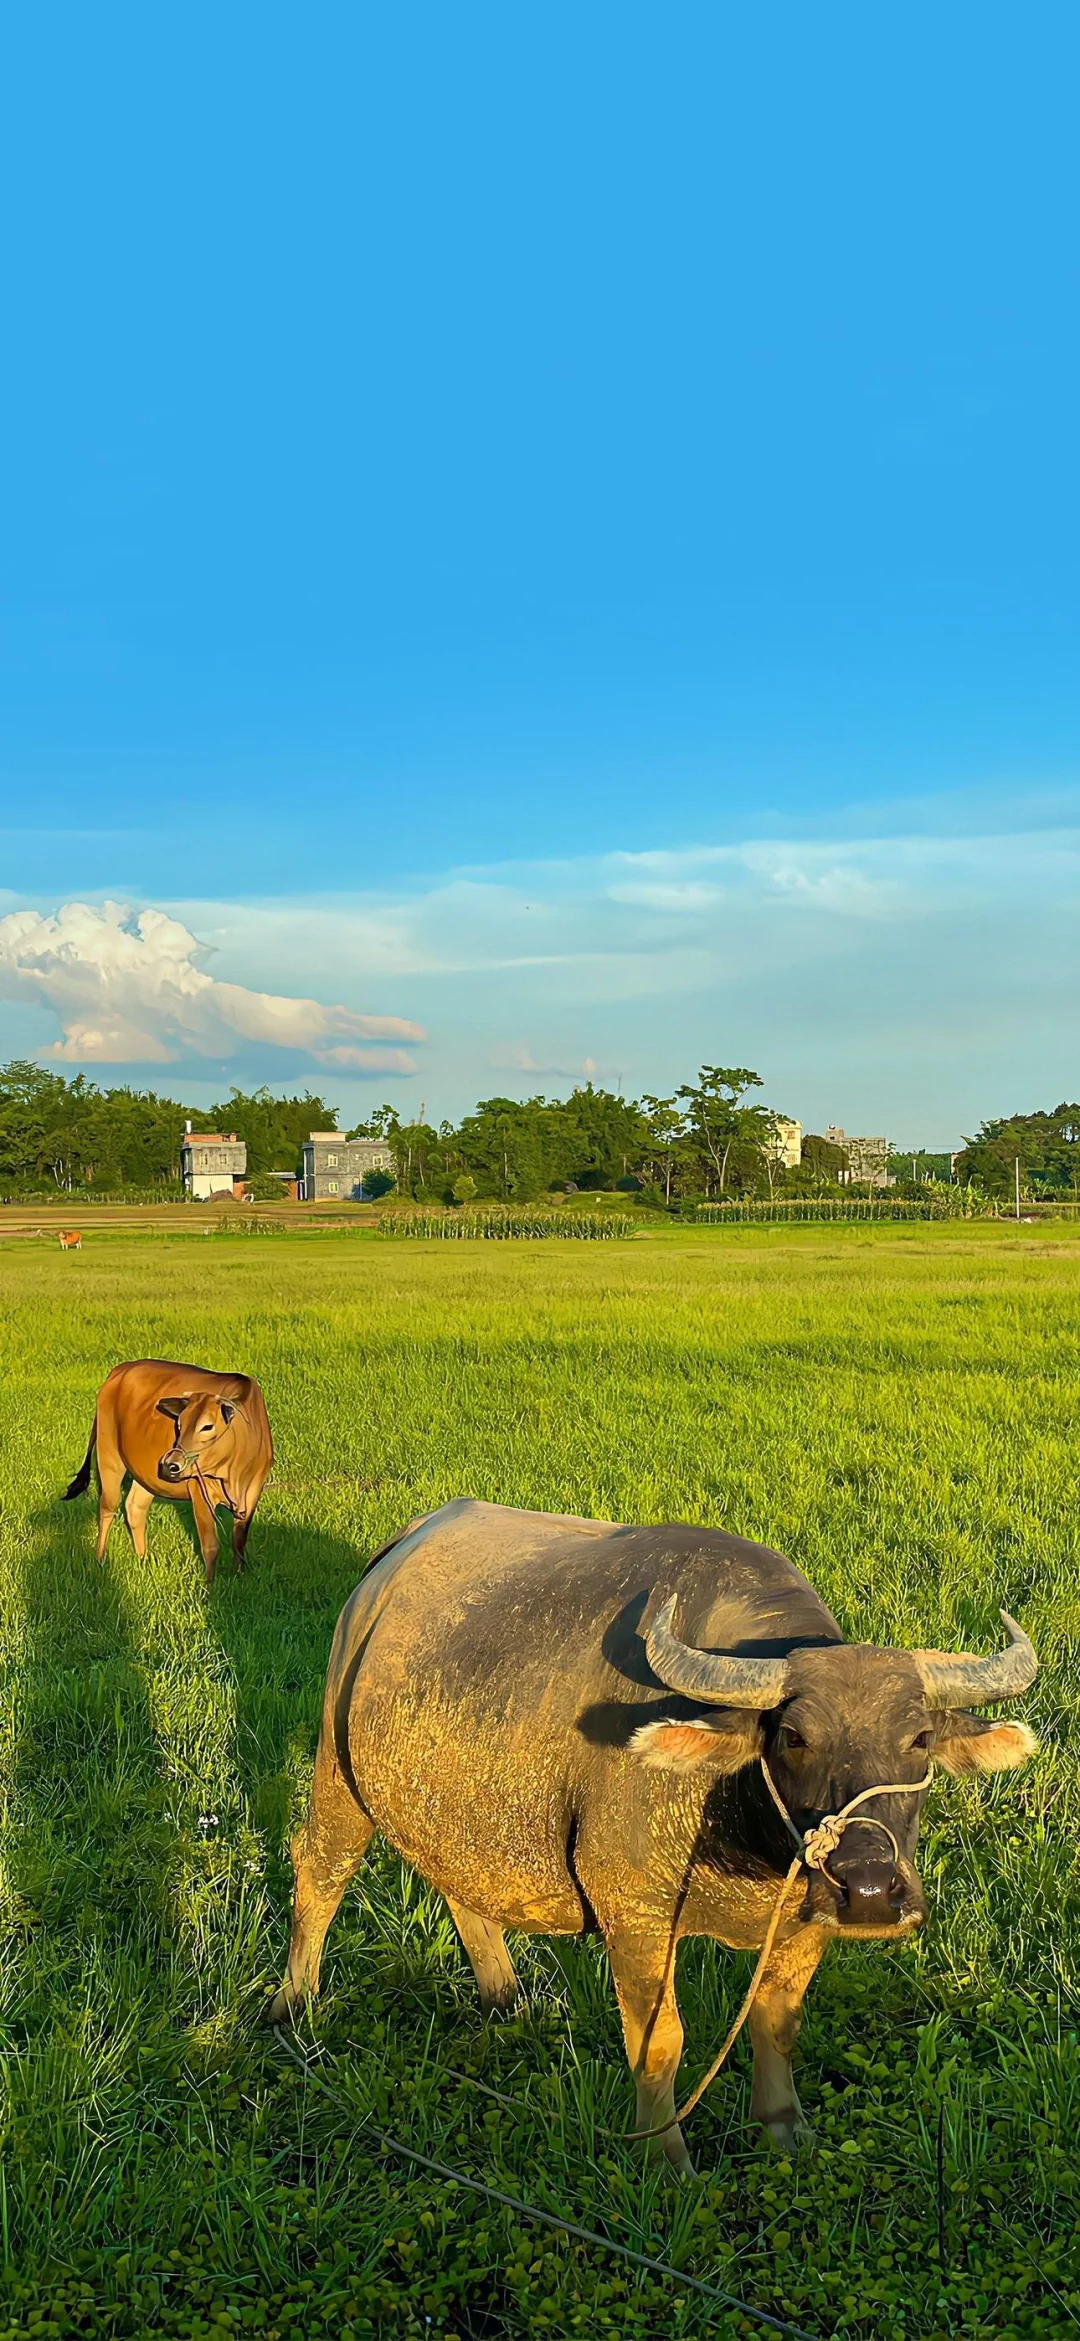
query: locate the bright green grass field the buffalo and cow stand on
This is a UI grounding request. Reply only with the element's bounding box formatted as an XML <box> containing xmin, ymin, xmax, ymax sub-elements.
<box><xmin>0</xmin><ymin>1224</ymin><xmax>1080</xmax><ymax>2341</ymax></box>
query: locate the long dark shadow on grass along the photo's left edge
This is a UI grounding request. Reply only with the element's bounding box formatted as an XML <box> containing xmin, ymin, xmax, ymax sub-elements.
<box><xmin>2</xmin><ymin>1503</ymin><xmax>194</xmax><ymax>2266</ymax></box>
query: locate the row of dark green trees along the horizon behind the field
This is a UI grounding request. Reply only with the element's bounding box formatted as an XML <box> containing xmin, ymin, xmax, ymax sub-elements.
<box><xmin>0</xmin><ymin>1060</ymin><xmax>1080</xmax><ymax>1206</ymax></box>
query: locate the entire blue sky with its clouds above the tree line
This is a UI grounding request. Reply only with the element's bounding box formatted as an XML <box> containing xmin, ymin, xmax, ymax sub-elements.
<box><xmin>0</xmin><ymin>0</ymin><xmax>1080</xmax><ymax>1145</ymax></box>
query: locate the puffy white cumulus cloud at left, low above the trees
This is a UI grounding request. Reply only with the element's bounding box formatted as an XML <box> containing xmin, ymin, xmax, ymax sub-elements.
<box><xmin>0</xmin><ymin>901</ymin><xmax>424</xmax><ymax>1072</ymax></box>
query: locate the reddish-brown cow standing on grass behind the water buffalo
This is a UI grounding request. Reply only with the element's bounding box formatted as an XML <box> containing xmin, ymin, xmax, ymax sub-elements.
<box><xmin>63</xmin><ymin>1358</ymin><xmax>274</xmax><ymax>1580</ymax></box>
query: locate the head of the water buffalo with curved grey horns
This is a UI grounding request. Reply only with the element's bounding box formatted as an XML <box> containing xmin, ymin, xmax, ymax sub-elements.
<box><xmin>633</xmin><ymin>1599</ymin><xmax>1038</xmax><ymax>1936</ymax></box>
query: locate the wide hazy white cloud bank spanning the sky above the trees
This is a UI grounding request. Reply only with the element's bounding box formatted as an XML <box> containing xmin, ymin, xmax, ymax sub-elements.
<box><xmin>0</xmin><ymin>822</ymin><xmax>1080</xmax><ymax>1145</ymax></box>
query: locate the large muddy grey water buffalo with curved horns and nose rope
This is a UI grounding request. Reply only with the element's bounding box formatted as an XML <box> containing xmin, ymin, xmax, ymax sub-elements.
<box><xmin>269</xmin><ymin>1501</ymin><xmax>1035</xmax><ymax>2170</ymax></box>
